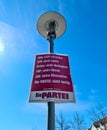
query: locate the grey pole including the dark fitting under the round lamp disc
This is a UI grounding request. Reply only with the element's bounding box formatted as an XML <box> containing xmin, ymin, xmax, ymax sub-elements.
<box><xmin>47</xmin><ymin>22</ymin><xmax>56</xmax><ymax>130</ymax></box>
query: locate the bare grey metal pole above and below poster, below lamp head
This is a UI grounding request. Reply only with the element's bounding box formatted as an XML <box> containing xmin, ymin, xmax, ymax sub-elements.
<box><xmin>47</xmin><ymin>34</ymin><xmax>55</xmax><ymax>130</ymax></box>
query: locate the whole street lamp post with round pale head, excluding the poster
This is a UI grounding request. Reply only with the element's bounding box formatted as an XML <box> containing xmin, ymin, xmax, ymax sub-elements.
<box><xmin>37</xmin><ymin>12</ymin><xmax>66</xmax><ymax>130</ymax></box>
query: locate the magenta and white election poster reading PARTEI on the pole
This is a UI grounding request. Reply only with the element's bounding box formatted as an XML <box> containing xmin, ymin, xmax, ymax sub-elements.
<box><xmin>29</xmin><ymin>53</ymin><xmax>75</xmax><ymax>103</ymax></box>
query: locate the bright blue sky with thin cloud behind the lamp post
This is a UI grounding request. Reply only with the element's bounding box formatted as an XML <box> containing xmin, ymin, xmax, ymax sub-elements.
<box><xmin>0</xmin><ymin>0</ymin><xmax>107</xmax><ymax>130</ymax></box>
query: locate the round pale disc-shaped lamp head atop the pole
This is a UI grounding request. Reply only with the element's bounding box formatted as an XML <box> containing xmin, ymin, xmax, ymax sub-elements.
<box><xmin>37</xmin><ymin>12</ymin><xmax>66</xmax><ymax>38</ymax></box>
